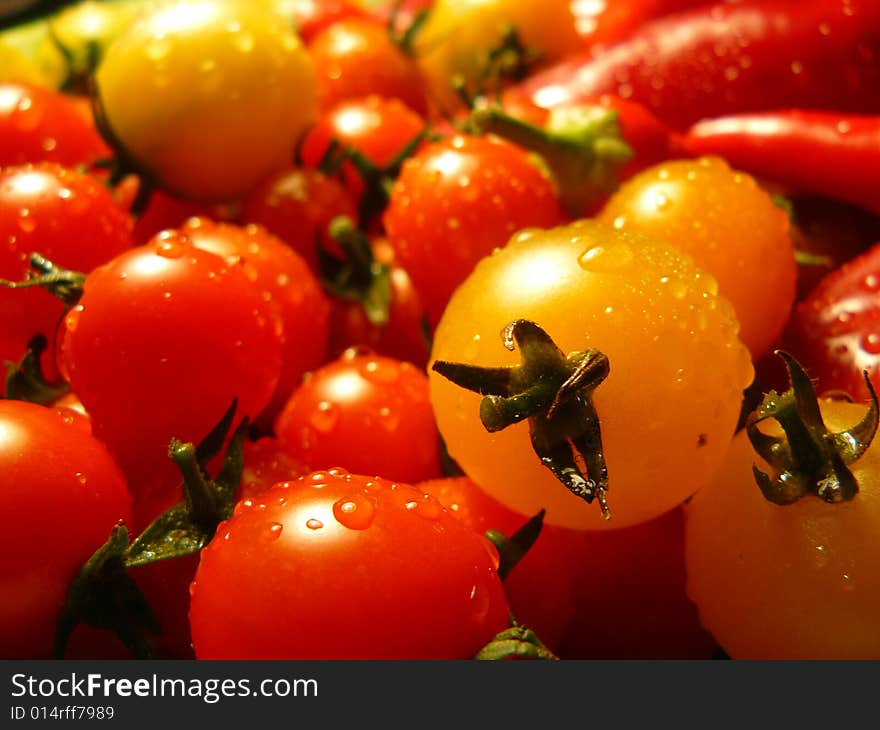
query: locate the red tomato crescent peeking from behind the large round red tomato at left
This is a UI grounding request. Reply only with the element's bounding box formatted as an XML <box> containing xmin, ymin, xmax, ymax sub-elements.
<box><xmin>180</xmin><ymin>218</ymin><xmax>330</xmax><ymax>431</ymax></box>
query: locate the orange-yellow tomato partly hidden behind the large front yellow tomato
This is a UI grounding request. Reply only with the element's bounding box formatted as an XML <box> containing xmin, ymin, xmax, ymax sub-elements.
<box><xmin>598</xmin><ymin>157</ymin><xmax>797</xmax><ymax>359</ymax></box>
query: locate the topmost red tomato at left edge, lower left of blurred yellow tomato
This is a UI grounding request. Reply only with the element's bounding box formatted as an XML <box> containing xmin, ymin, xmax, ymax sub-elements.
<box><xmin>0</xmin><ymin>83</ymin><xmax>110</xmax><ymax>166</ymax></box>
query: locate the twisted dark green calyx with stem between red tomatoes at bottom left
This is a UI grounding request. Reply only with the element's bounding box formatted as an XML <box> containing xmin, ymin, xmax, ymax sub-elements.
<box><xmin>54</xmin><ymin>402</ymin><xmax>248</xmax><ymax>659</ymax></box>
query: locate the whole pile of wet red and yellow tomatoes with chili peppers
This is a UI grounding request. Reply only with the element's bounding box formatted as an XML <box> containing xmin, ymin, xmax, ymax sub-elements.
<box><xmin>0</xmin><ymin>0</ymin><xmax>880</xmax><ymax>659</ymax></box>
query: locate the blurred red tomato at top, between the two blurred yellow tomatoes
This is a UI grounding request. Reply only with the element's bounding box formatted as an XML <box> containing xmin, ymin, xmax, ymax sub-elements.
<box><xmin>307</xmin><ymin>17</ymin><xmax>428</xmax><ymax>114</ymax></box>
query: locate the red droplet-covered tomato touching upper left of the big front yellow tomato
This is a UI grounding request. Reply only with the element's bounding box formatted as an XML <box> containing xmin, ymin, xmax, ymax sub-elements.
<box><xmin>383</xmin><ymin>135</ymin><xmax>563</xmax><ymax>326</ymax></box>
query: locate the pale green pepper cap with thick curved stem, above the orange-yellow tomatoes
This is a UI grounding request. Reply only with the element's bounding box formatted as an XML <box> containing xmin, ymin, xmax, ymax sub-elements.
<box><xmin>470</xmin><ymin>106</ymin><xmax>634</xmax><ymax>217</ymax></box>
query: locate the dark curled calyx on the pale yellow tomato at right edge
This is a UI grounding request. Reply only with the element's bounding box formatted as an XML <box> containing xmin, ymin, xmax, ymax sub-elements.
<box><xmin>746</xmin><ymin>350</ymin><xmax>878</xmax><ymax>505</ymax></box>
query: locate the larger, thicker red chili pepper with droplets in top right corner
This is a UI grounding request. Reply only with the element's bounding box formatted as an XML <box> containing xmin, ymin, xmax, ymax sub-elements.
<box><xmin>508</xmin><ymin>0</ymin><xmax>880</xmax><ymax>129</ymax></box>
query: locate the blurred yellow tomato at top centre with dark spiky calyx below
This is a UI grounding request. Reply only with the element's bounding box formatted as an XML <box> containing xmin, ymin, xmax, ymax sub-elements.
<box><xmin>415</xmin><ymin>0</ymin><xmax>584</xmax><ymax>111</ymax></box>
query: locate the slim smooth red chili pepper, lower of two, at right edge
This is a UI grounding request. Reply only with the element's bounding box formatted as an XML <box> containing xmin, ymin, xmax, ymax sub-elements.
<box><xmin>685</xmin><ymin>109</ymin><xmax>880</xmax><ymax>214</ymax></box>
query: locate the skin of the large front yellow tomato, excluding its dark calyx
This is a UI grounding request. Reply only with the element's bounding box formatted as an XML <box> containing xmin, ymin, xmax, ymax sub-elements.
<box><xmin>430</xmin><ymin>220</ymin><xmax>753</xmax><ymax>529</ymax></box>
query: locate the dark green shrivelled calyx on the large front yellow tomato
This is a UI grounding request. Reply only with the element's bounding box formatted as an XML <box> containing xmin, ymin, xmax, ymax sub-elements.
<box><xmin>432</xmin><ymin>319</ymin><xmax>611</xmax><ymax>520</ymax></box>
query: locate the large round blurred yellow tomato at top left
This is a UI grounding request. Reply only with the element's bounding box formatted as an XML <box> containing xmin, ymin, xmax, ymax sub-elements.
<box><xmin>96</xmin><ymin>0</ymin><xmax>318</xmax><ymax>201</ymax></box>
